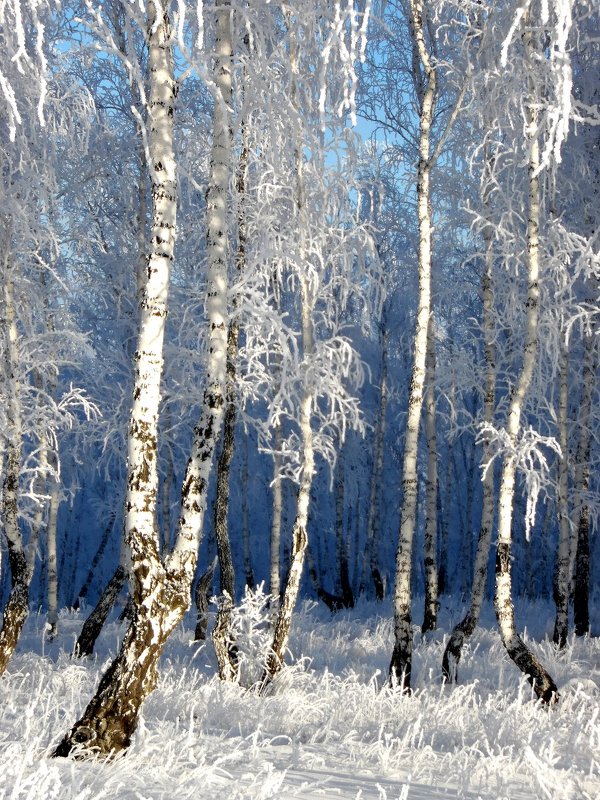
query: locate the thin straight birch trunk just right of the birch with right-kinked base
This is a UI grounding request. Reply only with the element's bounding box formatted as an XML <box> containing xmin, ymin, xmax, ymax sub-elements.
<box><xmin>552</xmin><ymin>344</ymin><xmax>571</xmax><ymax>650</ymax></box>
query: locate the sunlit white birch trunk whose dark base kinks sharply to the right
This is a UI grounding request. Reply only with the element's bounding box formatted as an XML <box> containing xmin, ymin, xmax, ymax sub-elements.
<box><xmin>494</xmin><ymin>17</ymin><xmax>557</xmax><ymax>703</ymax></box>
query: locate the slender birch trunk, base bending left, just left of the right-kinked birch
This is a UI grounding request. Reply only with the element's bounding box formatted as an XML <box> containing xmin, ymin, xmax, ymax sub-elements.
<box><xmin>442</xmin><ymin>216</ymin><xmax>496</xmax><ymax>682</ymax></box>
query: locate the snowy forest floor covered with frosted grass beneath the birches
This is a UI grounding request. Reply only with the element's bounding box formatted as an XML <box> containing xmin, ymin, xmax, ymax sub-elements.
<box><xmin>0</xmin><ymin>597</ymin><xmax>600</xmax><ymax>800</ymax></box>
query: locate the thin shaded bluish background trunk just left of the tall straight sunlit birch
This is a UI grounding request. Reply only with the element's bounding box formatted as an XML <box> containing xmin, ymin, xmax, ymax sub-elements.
<box><xmin>361</xmin><ymin>316</ymin><xmax>389</xmax><ymax>601</ymax></box>
